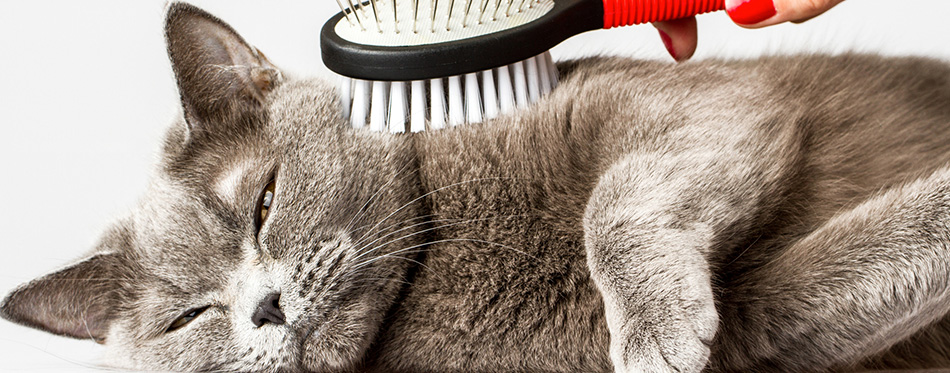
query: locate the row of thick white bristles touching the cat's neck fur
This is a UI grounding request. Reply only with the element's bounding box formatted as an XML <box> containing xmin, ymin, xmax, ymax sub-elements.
<box><xmin>340</xmin><ymin>52</ymin><xmax>557</xmax><ymax>133</ymax></box>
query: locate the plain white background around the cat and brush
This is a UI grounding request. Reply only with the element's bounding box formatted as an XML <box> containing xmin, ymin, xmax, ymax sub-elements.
<box><xmin>0</xmin><ymin>0</ymin><xmax>950</xmax><ymax>371</ymax></box>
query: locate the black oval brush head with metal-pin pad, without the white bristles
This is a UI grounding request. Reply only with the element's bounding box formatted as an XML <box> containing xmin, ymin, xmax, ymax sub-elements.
<box><xmin>320</xmin><ymin>0</ymin><xmax>603</xmax><ymax>81</ymax></box>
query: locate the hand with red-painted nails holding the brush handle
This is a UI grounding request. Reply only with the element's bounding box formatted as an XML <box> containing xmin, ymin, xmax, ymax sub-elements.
<box><xmin>653</xmin><ymin>0</ymin><xmax>844</xmax><ymax>61</ymax></box>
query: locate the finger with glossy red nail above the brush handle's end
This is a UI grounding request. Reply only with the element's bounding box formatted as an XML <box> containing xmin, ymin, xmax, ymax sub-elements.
<box><xmin>726</xmin><ymin>0</ymin><xmax>843</xmax><ymax>28</ymax></box>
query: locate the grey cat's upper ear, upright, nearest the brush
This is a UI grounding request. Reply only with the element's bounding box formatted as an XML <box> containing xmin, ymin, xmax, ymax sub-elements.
<box><xmin>165</xmin><ymin>3</ymin><xmax>281</xmax><ymax>134</ymax></box>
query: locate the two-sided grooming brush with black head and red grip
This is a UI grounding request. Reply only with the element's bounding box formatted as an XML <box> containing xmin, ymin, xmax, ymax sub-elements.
<box><xmin>320</xmin><ymin>0</ymin><xmax>725</xmax><ymax>132</ymax></box>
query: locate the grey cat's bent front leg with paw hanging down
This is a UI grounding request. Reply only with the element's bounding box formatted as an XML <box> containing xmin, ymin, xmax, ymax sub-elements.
<box><xmin>584</xmin><ymin>146</ymin><xmax>779</xmax><ymax>372</ymax></box>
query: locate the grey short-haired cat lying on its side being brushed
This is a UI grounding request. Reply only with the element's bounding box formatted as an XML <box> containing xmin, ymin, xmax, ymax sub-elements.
<box><xmin>0</xmin><ymin>3</ymin><xmax>950</xmax><ymax>372</ymax></box>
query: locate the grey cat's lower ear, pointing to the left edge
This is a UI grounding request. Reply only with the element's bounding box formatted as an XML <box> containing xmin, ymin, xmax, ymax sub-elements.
<box><xmin>0</xmin><ymin>254</ymin><xmax>125</xmax><ymax>343</ymax></box>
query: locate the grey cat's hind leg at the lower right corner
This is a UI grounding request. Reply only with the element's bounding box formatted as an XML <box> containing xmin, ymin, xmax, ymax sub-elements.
<box><xmin>713</xmin><ymin>164</ymin><xmax>950</xmax><ymax>371</ymax></box>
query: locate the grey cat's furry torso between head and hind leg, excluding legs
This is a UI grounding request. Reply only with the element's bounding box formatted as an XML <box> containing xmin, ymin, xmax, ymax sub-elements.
<box><xmin>383</xmin><ymin>55</ymin><xmax>950</xmax><ymax>371</ymax></box>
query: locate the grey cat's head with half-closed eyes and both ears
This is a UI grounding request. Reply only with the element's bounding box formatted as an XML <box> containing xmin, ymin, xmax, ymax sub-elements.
<box><xmin>0</xmin><ymin>4</ymin><xmax>422</xmax><ymax>371</ymax></box>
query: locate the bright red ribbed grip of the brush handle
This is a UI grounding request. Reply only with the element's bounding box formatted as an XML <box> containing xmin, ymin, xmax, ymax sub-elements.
<box><xmin>604</xmin><ymin>0</ymin><xmax>726</xmax><ymax>29</ymax></box>
